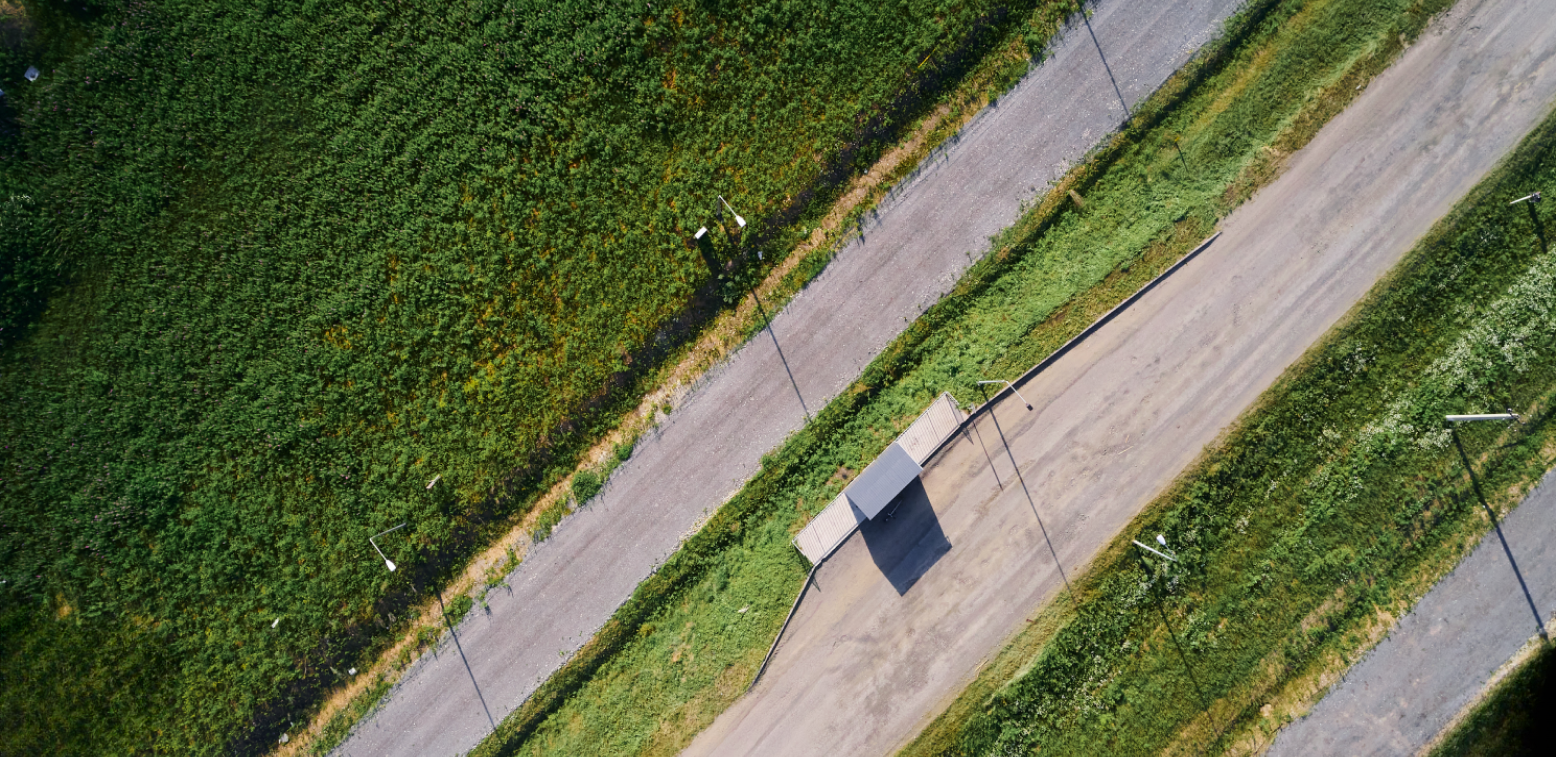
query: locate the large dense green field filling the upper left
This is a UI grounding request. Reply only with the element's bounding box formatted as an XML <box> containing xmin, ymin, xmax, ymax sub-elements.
<box><xmin>0</xmin><ymin>0</ymin><xmax>1071</xmax><ymax>754</ymax></box>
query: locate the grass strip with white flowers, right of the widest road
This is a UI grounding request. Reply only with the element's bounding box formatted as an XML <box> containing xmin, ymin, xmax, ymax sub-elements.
<box><xmin>902</xmin><ymin>28</ymin><xmax>1556</xmax><ymax>755</ymax></box>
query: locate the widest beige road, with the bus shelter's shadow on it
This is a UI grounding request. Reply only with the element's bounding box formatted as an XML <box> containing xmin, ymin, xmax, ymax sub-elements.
<box><xmin>685</xmin><ymin>0</ymin><xmax>1556</xmax><ymax>757</ymax></box>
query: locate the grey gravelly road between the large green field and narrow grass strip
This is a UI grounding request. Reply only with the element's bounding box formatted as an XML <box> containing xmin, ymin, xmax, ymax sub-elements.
<box><xmin>335</xmin><ymin>0</ymin><xmax>1240</xmax><ymax>757</ymax></box>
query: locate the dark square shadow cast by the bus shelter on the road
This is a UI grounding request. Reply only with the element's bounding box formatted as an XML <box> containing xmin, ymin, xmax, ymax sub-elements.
<box><xmin>859</xmin><ymin>479</ymin><xmax>951</xmax><ymax>597</ymax></box>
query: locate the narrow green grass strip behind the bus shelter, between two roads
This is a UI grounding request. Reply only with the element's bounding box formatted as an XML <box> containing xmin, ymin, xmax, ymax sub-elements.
<box><xmin>475</xmin><ymin>0</ymin><xmax>1449</xmax><ymax>755</ymax></box>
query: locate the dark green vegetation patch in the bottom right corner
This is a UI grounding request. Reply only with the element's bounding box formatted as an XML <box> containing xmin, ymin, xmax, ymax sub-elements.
<box><xmin>1432</xmin><ymin>645</ymin><xmax>1556</xmax><ymax>757</ymax></box>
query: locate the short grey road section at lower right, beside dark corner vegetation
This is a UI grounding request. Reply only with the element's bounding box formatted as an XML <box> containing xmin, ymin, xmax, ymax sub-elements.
<box><xmin>1268</xmin><ymin>474</ymin><xmax>1556</xmax><ymax>757</ymax></box>
